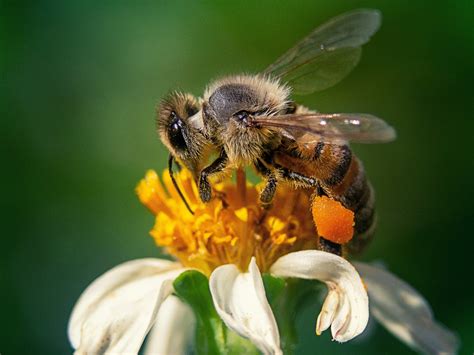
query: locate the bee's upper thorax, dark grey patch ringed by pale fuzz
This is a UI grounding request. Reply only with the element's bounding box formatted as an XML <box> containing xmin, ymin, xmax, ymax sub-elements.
<box><xmin>203</xmin><ymin>76</ymin><xmax>289</xmax><ymax>135</ymax></box>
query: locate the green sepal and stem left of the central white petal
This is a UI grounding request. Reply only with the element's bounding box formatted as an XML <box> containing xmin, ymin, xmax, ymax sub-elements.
<box><xmin>173</xmin><ymin>270</ymin><xmax>259</xmax><ymax>355</ymax></box>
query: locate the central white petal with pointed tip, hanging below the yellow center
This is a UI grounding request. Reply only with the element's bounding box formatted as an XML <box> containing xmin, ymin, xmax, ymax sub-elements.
<box><xmin>209</xmin><ymin>258</ymin><xmax>282</xmax><ymax>354</ymax></box>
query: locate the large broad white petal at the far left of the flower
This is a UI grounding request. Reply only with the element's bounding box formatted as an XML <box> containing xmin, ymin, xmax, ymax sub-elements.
<box><xmin>68</xmin><ymin>259</ymin><xmax>183</xmax><ymax>354</ymax></box>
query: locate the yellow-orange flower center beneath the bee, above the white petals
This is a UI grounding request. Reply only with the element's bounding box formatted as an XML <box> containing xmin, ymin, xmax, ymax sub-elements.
<box><xmin>137</xmin><ymin>169</ymin><xmax>318</xmax><ymax>275</ymax></box>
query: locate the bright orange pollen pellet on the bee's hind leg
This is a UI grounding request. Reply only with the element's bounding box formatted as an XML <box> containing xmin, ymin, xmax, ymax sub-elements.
<box><xmin>312</xmin><ymin>196</ymin><xmax>354</xmax><ymax>244</ymax></box>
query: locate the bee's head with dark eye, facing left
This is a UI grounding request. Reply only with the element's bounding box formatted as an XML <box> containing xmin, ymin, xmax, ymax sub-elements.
<box><xmin>156</xmin><ymin>92</ymin><xmax>206</xmax><ymax>174</ymax></box>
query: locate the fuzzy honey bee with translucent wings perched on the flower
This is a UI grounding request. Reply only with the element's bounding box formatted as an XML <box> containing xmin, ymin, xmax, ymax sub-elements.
<box><xmin>158</xmin><ymin>10</ymin><xmax>395</xmax><ymax>254</ymax></box>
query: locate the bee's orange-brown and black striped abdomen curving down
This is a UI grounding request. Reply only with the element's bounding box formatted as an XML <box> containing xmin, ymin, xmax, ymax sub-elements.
<box><xmin>275</xmin><ymin>142</ymin><xmax>375</xmax><ymax>253</ymax></box>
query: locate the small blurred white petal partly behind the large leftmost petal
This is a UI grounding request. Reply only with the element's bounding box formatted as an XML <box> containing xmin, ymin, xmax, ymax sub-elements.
<box><xmin>144</xmin><ymin>296</ymin><xmax>196</xmax><ymax>355</ymax></box>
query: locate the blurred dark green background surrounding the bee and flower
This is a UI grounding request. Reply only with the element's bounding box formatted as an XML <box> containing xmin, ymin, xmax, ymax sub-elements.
<box><xmin>0</xmin><ymin>0</ymin><xmax>474</xmax><ymax>354</ymax></box>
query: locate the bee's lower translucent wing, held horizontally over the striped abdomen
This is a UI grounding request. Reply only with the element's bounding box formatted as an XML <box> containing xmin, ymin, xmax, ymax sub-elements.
<box><xmin>252</xmin><ymin>113</ymin><xmax>396</xmax><ymax>144</ymax></box>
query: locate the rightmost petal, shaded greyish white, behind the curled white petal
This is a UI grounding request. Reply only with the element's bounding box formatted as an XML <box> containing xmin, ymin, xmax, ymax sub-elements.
<box><xmin>355</xmin><ymin>263</ymin><xmax>459</xmax><ymax>354</ymax></box>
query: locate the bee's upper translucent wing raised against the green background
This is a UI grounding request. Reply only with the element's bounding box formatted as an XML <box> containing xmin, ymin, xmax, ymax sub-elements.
<box><xmin>264</xmin><ymin>9</ymin><xmax>381</xmax><ymax>94</ymax></box>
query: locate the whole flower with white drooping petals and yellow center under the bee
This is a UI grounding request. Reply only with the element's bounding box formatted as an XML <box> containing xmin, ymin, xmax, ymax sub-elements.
<box><xmin>69</xmin><ymin>170</ymin><xmax>457</xmax><ymax>354</ymax></box>
